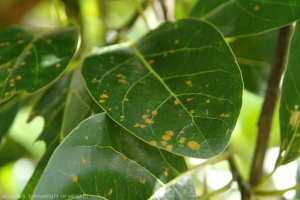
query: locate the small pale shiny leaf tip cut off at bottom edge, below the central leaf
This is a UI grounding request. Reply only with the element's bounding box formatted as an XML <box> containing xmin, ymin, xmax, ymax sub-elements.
<box><xmin>150</xmin><ymin>176</ymin><xmax>197</xmax><ymax>200</ymax></box>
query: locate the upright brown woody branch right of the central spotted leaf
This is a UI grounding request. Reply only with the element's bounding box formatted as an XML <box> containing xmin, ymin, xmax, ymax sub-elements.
<box><xmin>250</xmin><ymin>25</ymin><xmax>293</xmax><ymax>186</ymax></box>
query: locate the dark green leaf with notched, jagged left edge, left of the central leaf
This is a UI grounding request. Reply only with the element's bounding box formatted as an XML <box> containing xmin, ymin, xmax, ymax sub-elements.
<box><xmin>28</xmin><ymin>73</ymin><xmax>72</xmax><ymax>146</ymax></box>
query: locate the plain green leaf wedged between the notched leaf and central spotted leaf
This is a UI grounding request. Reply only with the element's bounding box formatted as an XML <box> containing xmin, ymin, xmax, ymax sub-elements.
<box><xmin>61</xmin><ymin>68</ymin><xmax>103</xmax><ymax>137</ymax></box>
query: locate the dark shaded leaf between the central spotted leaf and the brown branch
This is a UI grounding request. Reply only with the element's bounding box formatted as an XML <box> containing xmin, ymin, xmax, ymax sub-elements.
<box><xmin>230</xmin><ymin>30</ymin><xmax>278</xmax><ymax>96</ymax></box>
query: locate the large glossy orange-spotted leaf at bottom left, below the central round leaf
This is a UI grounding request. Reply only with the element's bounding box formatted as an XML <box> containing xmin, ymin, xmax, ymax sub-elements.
<box><xmin>33</xmin><ymin>113</ymin><xmax>192</xmax><ymax>199</ymax></box>
